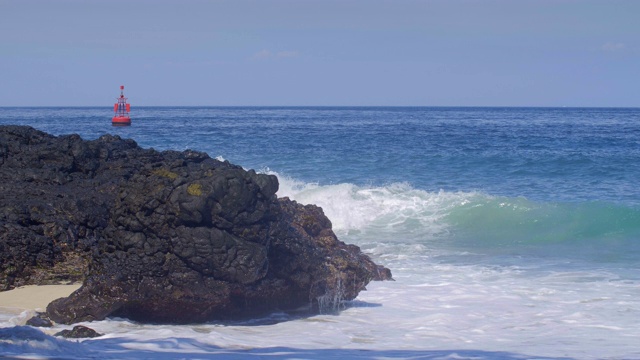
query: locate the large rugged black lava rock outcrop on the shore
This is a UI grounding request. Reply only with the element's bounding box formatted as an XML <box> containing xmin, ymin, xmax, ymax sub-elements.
<box><xmin>0</xmin><ymin>126</ymin><xmax>391</xmax><ymax>323</ymax></box>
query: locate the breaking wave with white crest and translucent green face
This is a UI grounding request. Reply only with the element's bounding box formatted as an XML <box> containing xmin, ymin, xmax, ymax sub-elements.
<box><xmin>265</xmin><ymin>170</ymin><xmax>640</xmax><ymax>262</ymax></box>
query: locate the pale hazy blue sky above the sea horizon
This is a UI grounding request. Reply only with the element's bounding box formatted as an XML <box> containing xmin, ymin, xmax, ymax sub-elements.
<box><xmin>0</xmin><ymin>0</ymin><xmax>640</xmax><ymax>107</ymax></box>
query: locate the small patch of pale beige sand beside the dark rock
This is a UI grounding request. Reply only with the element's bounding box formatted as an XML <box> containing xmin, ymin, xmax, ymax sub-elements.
<box><xmin>0</xmin><ymin>284</ymin><xmax>81</xmax><ymax>311</ymax></box>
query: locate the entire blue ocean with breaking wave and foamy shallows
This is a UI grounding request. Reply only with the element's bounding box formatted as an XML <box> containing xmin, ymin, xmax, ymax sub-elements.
<box><xmin>0</xmin><ymin>107</ymin><xmax>640</xmax><ymax>359</ymax></box>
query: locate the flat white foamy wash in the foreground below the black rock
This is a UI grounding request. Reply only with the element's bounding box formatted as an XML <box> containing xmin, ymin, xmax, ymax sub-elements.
<box><xmin>5</xmin><ymin>263</ymin><xmax>640</xmax><ymax>359</ymax></box>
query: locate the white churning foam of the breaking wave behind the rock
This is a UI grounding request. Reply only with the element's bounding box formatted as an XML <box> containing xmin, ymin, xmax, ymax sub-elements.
<box><xmin>266</xmin><ymin>170</ymin><xmax>478</xmax><ymax>239</ymax></box>
